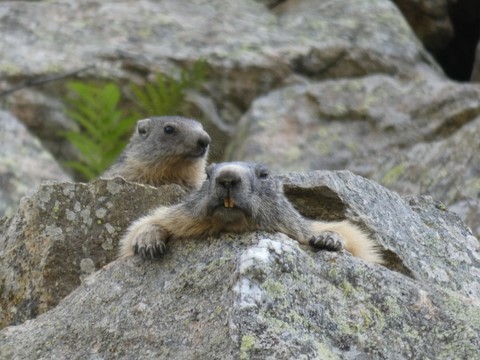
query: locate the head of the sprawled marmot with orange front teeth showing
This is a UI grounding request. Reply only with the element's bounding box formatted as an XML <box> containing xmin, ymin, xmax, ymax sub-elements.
<box><xmin>200</xmin><ymin>162</ymin><xmax>284</xmax><ymax>224</ymax></box>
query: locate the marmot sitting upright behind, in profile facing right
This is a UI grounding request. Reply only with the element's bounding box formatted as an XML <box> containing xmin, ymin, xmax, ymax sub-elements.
<box><xmin>101</xmin><ymin>116</ymin><xmax>211</xmax><ymax>190</ymax></box>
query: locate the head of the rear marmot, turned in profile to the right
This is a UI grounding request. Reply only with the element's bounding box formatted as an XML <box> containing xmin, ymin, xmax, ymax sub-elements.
<box><xmin>128</xmin><ymin>116</ymin><xmax>211</xmax><ymax>166</ymax></box>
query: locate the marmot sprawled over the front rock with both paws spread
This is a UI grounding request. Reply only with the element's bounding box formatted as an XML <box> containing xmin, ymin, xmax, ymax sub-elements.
<box><xmin>120</xmin><ymin>162</ymin><xmax>382</xmax><ymax>263</ymax></box>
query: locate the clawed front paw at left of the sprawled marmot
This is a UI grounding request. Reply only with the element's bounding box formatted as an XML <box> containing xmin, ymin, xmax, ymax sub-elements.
<box><xmin>130</xmin><ymin>224</ymin><xmax>167</xmax><ymax>259</ymax></box>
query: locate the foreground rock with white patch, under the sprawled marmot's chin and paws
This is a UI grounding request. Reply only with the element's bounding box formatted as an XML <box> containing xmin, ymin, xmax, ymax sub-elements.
<box><xmin>0</xmin><ymin>234</ymin><xmax>480</xmax><ymax>359</ymax></box>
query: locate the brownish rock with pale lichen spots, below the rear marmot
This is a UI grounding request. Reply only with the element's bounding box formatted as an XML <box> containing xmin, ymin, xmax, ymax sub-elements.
<box><xmin>0</xmin><ymin>178</ymin><xmax>184</xmax><ymax>327</ymax></box>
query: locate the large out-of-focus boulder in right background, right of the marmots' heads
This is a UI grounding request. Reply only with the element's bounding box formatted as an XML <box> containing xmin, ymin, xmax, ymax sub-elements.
<box><xmin>228</xmin><ymin>75</ymin><xmax>480</xmax><ymax>239</ymax></box>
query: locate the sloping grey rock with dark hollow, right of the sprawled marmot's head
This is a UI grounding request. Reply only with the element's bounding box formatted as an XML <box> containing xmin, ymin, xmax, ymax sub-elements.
<box><xmin>284</xmin><ymin>171</ymin><xmax>480</xmax><ymax>299</ymax></box>
